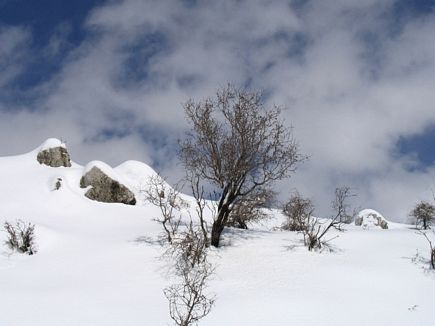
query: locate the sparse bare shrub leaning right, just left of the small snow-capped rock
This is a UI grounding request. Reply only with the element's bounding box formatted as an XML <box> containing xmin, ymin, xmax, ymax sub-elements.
<box><xmin>302</xmin><ymin>187</ymin><xmax>355</xmax><ymax>251</ymax></box>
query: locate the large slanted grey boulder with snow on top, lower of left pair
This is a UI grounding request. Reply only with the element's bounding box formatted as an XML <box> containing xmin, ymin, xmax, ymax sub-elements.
<box><xmin>80</xmin><ymin>161</ymin><xmax>136</xmax><ymax>205</ymax></box>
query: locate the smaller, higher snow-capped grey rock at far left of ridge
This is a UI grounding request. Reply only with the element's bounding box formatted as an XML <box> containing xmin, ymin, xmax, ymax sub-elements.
<box><xmin>36</xmin><ymin>138</ymin><xmax>71</xmax><ymax>168</ymax></box>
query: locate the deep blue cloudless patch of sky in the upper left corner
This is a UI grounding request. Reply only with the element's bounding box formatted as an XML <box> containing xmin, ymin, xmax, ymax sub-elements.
<box><xmin>0</xmin><ymin>0</ymin><xmax>104</xmax><ymax>96</ymax></box>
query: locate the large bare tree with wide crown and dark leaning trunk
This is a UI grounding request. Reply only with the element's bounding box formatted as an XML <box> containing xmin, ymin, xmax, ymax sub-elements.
<box><xmin>180</xmin><ymin>86</ymin><xmax>304</xmax><ymax>247</ymax></box>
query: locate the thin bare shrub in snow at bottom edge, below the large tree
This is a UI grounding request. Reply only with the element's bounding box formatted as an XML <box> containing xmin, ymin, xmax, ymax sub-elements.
<box><xmin>163</xmin><ymin>223</ymin><xmax>215</xmax><ymax>326</ymax></box>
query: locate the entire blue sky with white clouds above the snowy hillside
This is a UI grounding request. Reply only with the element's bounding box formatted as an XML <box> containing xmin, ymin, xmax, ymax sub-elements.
<box><xmin>0</xmin><ymin>0</ymin><xmax>435</xmax><ymax>219</ymax></box>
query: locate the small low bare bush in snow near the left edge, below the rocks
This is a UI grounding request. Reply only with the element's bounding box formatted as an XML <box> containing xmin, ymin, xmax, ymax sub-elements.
<box><xmin>4</xmin><ymin>220</ymin><xmax>36</xmax><ymax>255</ymax></box>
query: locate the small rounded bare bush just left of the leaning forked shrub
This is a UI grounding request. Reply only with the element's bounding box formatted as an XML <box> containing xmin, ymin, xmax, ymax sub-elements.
<box><xmin>282</xmin><ymin>192</ymin><xmax>314</xmax><ymax>231</ymax></box>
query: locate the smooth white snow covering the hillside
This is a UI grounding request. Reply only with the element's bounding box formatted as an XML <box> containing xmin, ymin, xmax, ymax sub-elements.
<box><xmin>0</xmin><ymin>143</ymin><xmax>435</xmax><ymax>326</ymax></box>
